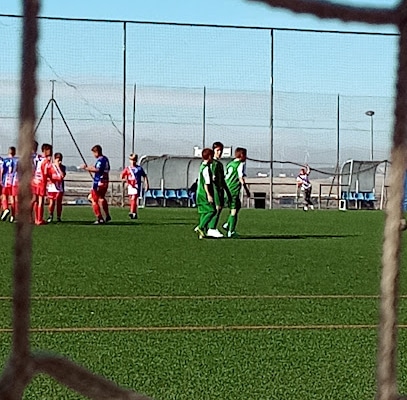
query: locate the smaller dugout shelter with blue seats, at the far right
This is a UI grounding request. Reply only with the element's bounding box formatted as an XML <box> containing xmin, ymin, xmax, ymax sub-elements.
<box><xmin>339</xmin><ymin>160</ymin><xmax>387</xmax><ymax>210</ymax></box>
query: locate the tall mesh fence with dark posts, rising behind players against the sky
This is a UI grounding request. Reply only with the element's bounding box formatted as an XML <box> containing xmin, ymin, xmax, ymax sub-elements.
<box><xmin>0</xmin><ymin>15</ymin><xmax>398</xmax><ymax>176</ymax></box>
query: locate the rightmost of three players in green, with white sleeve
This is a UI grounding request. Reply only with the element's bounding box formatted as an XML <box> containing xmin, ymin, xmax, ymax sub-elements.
<box><xmin>223</xmin><ymin>147</ymin><xmax>250</xmax><ymax>238</ymax></box>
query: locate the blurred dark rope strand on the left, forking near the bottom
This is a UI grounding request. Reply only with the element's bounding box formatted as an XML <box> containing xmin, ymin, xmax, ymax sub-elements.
<box><xmin>0</xmin><ymin>0</ymin><xmax>151</xmax><ymax>400</ymax></box>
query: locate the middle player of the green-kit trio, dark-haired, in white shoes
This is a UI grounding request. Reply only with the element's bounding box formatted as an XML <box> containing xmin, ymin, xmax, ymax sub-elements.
<box><xmin>206</xmin><ymin>142</ymin><xmax>231</xmax><ymax>238</ymax></box>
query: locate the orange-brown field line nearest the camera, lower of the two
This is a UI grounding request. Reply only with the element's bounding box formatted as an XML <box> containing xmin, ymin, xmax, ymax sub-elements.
<box><xmin>0</xmin><ymin>324</ymin><xmax>407</xmax><ymax>333</ymax></box>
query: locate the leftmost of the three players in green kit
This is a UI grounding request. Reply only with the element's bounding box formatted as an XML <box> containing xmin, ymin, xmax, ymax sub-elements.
<box><xmin>195</xmin><ymin>148</ymin><xmax>216</xmax><ymax>239</ymax></box>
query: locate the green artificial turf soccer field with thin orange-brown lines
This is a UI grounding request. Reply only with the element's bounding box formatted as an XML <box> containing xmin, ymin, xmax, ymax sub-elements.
<box><xmin>0</xmin><ymin>207</ymin><xmax>407</xmax><ymax>400</ymax></box>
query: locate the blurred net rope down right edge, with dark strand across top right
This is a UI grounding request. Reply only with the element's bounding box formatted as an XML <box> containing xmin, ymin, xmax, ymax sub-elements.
<box><xmin>248</xmin><ymin>0</ymin><xmax>407</xmax><ymax>400</ymax></box>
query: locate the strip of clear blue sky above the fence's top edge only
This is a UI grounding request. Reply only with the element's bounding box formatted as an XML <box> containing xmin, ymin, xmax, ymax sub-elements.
<box><xmin>0</xmin><ymin>0</ymin><xmax>398</xmax><ymax>32</ymax></box>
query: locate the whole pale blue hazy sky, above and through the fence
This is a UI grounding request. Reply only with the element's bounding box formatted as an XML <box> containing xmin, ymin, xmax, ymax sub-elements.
<box><xmin>0</xmin><ymin>0</ymin><xmax>398</xmax><ymax>169</ymax></box>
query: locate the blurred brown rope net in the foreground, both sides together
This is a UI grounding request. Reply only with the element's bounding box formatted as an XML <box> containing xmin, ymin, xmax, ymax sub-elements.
<box><xmin>0</xmin><ymin>0</ymin><xmax>407</xmax><ymax>400</ymax></box>
